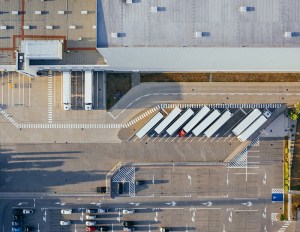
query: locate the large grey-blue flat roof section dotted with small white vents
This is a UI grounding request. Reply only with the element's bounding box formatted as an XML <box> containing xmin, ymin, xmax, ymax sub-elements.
<box><xmin>97</xmin><ymin>0</ymin><xmax>300</xmax><ymax>47</ymax></box>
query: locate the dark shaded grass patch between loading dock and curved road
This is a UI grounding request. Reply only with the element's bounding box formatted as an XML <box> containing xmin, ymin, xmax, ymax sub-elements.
<box><xmin>106</xmin><ymin>73</ymin><xmax>131</xmax><ymax>110</ymax></box>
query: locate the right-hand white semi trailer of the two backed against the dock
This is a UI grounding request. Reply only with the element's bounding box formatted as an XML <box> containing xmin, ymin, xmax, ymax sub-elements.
<box><xmin>84</xmin><ymin>71</ymin><xmax>94</xmax><ymax>110</ymax></box>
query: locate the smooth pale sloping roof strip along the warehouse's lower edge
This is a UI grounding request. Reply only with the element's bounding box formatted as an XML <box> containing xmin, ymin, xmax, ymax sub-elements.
<box><xmin>98</xmin><ymin>47</ymin><xmax>300</xmax><ymax>72</ymax></box>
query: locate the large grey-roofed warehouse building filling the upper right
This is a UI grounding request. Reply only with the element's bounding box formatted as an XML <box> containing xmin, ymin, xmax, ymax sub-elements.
<box><xmin>97</xmin><ymin>0</ymin><xmax>300</xmax><ymax>72</ymax></box>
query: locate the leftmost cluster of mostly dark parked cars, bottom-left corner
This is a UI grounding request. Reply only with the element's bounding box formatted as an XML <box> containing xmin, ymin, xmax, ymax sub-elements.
<box><xmin>11</xmin><ymin>209</ymin><xmax>34</xmax><ymax>232</ymax></box>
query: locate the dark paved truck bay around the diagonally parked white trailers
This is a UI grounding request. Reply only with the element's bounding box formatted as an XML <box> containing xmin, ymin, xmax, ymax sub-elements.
<box><xmin>123</xmin><ymin>104</ymin><xmax>283</xmax><ymax>142</ymax></box>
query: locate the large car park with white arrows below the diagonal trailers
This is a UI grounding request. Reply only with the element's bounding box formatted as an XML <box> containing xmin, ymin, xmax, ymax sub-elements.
<box><xmin>5</xmin><ymin>135</ymin><xmax>283</xmax><ymax>232</ymax></box>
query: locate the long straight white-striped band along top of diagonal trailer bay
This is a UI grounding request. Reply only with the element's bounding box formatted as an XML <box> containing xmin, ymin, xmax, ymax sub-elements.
<box><xmin>160</xmin><ymin>103</ymin><xmax>283</xmax><ymax>109</ymax></box>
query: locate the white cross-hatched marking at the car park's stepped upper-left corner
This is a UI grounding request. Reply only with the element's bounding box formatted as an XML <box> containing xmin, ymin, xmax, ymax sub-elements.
<box><xmin>111</xmin><ymin>167</ymin><xmax>135</xmax><ymax>197</ymax></box>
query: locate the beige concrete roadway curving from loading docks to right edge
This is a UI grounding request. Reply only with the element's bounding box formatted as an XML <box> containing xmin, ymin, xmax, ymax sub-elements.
<box><xmin>0</xmin><ymin>77</ymin><xmax>300</xmax><ymax>144</ymax></box>
